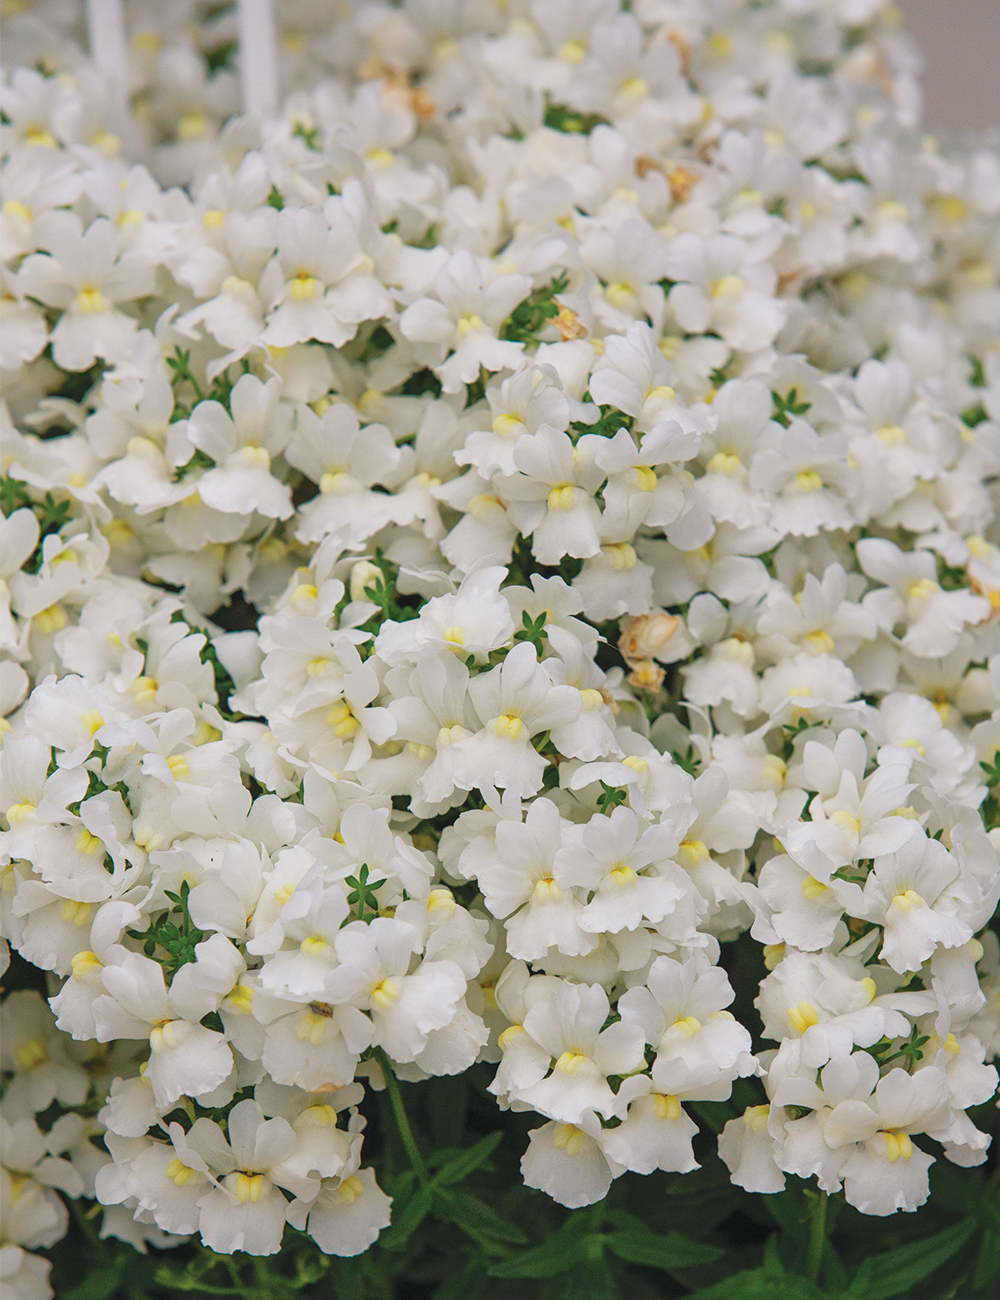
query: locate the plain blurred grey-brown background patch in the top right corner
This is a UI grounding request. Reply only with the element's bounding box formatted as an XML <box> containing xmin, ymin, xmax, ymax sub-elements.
<box><xmin>896</xmin><ymin>0</ymin><xmax>1000</xmax><ymax>131</ymax></box>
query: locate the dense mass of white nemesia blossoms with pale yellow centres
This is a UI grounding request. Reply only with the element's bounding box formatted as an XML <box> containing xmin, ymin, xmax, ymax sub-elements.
<box><xmin>0</xmin><ymin>0</ymin><xmax>1000</xmax><ymax>1300</ymax></box>
